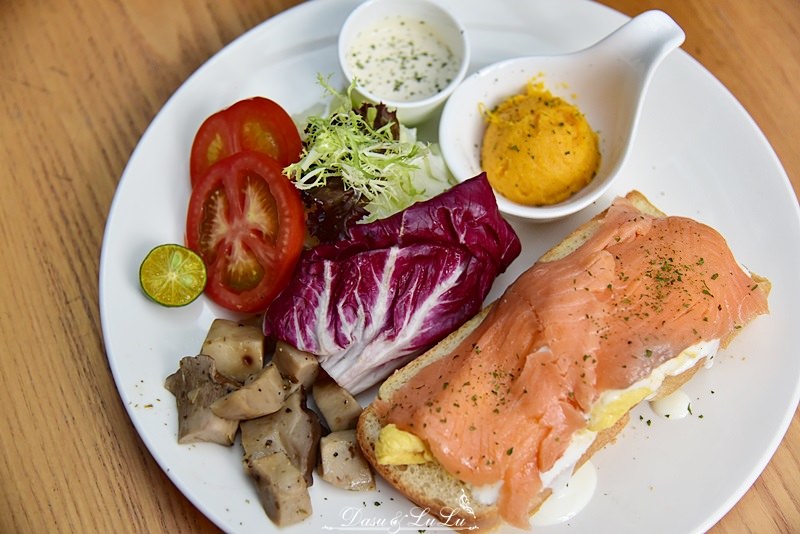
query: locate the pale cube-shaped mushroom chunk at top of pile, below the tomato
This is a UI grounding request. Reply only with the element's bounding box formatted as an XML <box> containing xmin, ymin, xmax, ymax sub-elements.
<box><xmin>200</xmin><ymin>319</ymin><xmax>264</xmax><ymax>382</ymax></box>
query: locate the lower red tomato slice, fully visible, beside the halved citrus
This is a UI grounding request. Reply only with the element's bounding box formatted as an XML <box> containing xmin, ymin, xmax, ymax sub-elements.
<box><xmin>186</xmin><ymin>150</ymin><xmax>305</xmax><ymax>313</ymax></box>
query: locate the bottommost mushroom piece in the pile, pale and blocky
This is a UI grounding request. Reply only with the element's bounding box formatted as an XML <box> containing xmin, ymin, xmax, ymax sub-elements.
<box><xmin>245</xmin><ymin>451</ymin><xmax>311</xmax><ymax>526</ymax></box>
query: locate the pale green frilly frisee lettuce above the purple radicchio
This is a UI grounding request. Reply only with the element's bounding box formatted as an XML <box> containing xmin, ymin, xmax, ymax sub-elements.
<box><xmin>284</xmin><ymin>76</ymin><xmax>454</xmax><ymax>222</ymax></box>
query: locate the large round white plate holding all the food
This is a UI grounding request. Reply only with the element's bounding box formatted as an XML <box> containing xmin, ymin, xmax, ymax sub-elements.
<box><xmin>100</xmin><ymin>0</ymin><xmax>800</xmax><ymax>533</ymax></box>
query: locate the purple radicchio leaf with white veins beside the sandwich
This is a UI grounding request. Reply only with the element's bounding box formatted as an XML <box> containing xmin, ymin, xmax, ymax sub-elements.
<box><xmin>264</xmin><ymin>174</ymin><xmax>521</xmax><ymax>393</ymax></box>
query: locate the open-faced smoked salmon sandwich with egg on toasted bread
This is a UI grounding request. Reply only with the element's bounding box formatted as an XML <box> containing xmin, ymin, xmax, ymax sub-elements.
<box><xmin>358</xmin><ymin>192</ymin><xmax>770</xmax><ymax>527</ymax></box>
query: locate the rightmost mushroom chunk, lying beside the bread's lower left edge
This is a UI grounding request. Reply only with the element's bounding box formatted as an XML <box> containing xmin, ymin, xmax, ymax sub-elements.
<box><xmin>319</xmin><ymin>430</ymin><xmax>375</xmax><ymax>491</ymax></box>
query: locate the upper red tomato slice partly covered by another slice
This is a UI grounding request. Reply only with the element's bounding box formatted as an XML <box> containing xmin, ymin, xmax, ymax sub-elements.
<box><xmin>189</xmin><ymin>97</ymin><xmax>303</xmax><ymax>187</ymax></box>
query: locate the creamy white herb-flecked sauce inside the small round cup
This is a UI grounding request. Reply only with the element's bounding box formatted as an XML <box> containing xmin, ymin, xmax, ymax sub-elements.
<box><xmin>347</xmin><ymin>16</ymin><xmax>459</xmax><ymax>102</ymax></box>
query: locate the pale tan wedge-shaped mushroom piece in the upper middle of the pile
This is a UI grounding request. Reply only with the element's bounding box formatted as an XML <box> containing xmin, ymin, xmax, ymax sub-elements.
<box><xmin>211</xmin><ymin>362</ymin><xmax>300</xmax><ymax>420</ymax></box>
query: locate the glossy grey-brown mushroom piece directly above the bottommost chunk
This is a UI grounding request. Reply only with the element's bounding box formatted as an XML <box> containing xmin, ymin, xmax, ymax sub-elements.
<box><xmin>240</xmin><ymin>388</ymin><xmax>322</xmax><ymax>486</ymax></box>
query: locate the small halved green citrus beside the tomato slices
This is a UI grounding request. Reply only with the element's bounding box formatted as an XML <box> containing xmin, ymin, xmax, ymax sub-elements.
<box><xmin>139</xmin><ymin>243</ymin><xmax>206</xmax><ymax>307</ymax></box>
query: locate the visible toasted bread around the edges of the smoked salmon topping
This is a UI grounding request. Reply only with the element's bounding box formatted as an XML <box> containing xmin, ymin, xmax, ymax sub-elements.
<box><xmin>357</xmin><ymin>190</ymin><xmax>770</xmax><ymax>529</ymax></box>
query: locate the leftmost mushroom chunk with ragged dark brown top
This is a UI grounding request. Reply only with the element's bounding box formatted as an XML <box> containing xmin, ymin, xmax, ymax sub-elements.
<box><xmin>164</xmin><ymin>354</ymin><xmax>240</xmax><ymax>445</ymax></box>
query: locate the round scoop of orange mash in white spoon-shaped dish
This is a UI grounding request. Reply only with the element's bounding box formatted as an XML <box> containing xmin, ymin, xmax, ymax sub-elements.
<box><xmin>481</xmin><ymin>81</ymin><xmax>600</xmax><ymax>206</ymax></box>
